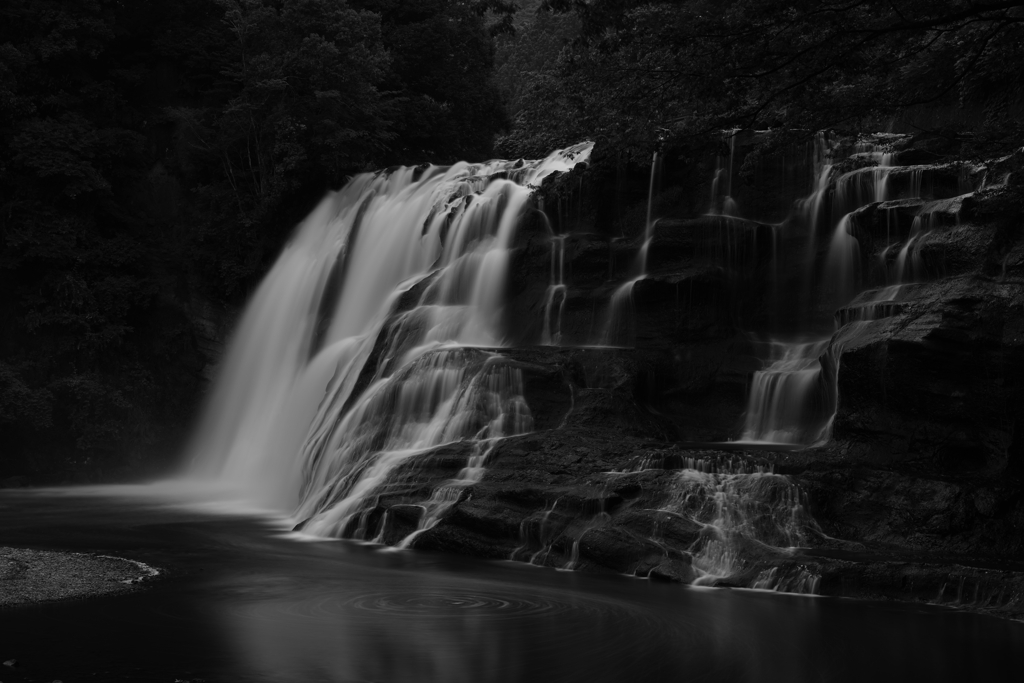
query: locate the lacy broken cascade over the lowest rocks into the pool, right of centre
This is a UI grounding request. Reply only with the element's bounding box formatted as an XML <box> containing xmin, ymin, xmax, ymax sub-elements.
<box><xmin>663</xmin><ymin>469</ymin><xmax>820</xmax><ymax>593</ymax></box>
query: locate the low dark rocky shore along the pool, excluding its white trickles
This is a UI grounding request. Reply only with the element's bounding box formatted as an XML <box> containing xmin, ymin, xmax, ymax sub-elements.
<box><xmin>346</xmin><ymin>428</ymin><xmax>1024</xmax><ymax>620</ymax></box>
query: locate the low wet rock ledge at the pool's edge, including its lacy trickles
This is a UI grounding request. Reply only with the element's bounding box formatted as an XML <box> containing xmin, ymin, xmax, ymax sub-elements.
<box><xmin>405</xmin><ymin>430</ymin><xmax>1024</xmax><ymax>620</ymax></box>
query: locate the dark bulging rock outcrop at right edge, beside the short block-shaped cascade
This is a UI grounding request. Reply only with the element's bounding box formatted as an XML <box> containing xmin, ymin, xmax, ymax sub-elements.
<box><xmin>835</xmin><ymin>273</ymin><xmax>1024</xmax><ymax>476</ymax></box>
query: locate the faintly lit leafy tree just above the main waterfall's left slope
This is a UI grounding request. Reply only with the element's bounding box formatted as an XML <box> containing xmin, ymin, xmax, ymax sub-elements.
<box><xmin>168</xmin><ymin>0</ymin><xmax>393</xmax><ymax>297</ymax></box>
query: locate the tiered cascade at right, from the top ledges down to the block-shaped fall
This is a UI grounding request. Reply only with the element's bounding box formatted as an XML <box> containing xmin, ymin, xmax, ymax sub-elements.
<box><xmin>741</xmin><ymin>134</ymin><xmax>999</xmax><ymax>445</ymax></box>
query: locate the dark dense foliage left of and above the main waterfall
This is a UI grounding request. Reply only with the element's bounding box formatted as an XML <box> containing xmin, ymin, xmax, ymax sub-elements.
<box><xmin>0</xmin><ymin>0</ymin><xmax>509</xmax><ymax>478</ymax></box>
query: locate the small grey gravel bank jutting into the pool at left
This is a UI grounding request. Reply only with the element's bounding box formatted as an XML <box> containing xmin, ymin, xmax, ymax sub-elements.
<box><xmin>0</xmin><ymin>548</ymin><xmax>160</xmax><ymax>606</ymax></box>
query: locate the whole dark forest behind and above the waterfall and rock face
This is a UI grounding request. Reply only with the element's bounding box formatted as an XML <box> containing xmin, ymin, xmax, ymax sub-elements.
<box><xmin>0</xmin><ymin>0</ymin><xmax>1024</xmax><ymax>481</ymax></box>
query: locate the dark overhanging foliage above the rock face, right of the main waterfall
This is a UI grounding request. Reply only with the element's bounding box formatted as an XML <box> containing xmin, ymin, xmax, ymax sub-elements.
<box><xmin>502</xmin><ymin>0</ymin><xmax>1024</xmax><ymax>162</ymax></box>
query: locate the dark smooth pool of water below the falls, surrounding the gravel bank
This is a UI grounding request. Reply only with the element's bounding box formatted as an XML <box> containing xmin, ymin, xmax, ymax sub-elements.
<box><xmin>0</xmin><ymin>489</ymin><xmax>1024</xmax><ymax>683</ymax></box>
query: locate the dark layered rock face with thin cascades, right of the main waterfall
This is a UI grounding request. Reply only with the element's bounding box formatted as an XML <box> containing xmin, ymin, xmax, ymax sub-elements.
<box><xmin>195</xmin><ymin>136</ymin><xmax>1024</xmax><ymax>614</ymax></box>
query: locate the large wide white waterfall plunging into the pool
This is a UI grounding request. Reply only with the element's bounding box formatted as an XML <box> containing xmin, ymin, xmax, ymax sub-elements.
<box><xmin>190</xmin><ymin>142</ymin><xmax>593</xmax><ymax>535</ymax></box>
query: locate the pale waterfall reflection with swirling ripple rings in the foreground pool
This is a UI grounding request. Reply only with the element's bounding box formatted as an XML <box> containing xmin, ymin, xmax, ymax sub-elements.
<box><xmin>221</xmin><ymin>571</ymin><xmax>675</xmax><ymax>683</ymax></box>
